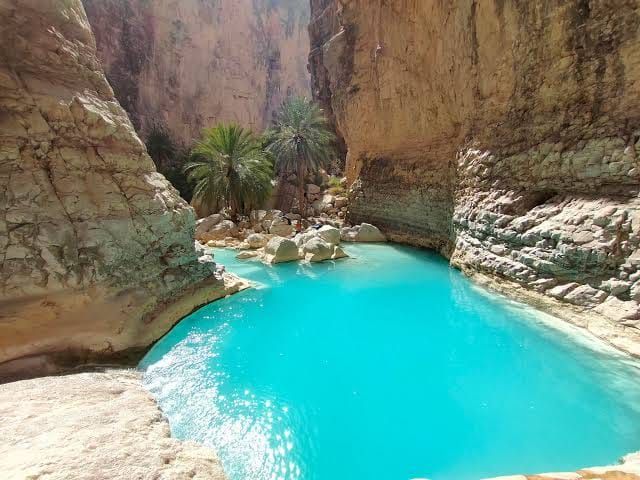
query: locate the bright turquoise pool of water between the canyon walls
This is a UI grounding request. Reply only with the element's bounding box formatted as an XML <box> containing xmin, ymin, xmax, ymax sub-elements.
<box><xmin>141</xmin><ymin>245</ymin><xmax>640</xmax><ymax>480</ymax></box>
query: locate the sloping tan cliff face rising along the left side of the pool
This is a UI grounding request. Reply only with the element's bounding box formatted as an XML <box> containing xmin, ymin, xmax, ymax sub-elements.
<box><xmin>0</xmin><ymin>0</ymin><xmax>244</xmax><ymax>378</ymax></box>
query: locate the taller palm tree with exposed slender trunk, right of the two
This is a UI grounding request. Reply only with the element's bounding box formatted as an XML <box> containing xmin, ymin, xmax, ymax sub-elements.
<box><xmin>267</xmin><ymin>97</ymin><xmax>335</xmax><ymax>216</ymax></box>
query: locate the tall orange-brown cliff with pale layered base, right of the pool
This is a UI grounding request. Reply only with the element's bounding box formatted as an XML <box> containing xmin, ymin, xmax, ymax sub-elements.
<box><xmin>310</xmin><ymin>0</ymin><xmax>640</xmax><ymax>355</ymax></box>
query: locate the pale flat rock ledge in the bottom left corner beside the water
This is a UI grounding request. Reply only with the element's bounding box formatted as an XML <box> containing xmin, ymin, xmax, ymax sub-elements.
<box><xmin>0</xmin><ymin>370</ymin><xmax>226</xmax><ymax>480</ymax></box>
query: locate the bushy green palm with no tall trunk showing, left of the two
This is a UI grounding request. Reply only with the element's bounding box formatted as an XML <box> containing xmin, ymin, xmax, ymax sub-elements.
<box><xmin>185</xmin><ymin>124</ymin><xmax>273</xmax><ymax>216</ymax></box>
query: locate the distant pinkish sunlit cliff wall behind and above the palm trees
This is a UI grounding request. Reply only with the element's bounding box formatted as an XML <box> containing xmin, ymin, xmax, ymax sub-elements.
<box><xmin>83</xmin><ymin>0</ymin><xmax>309</xmax><ymax>143</ymax></box>
